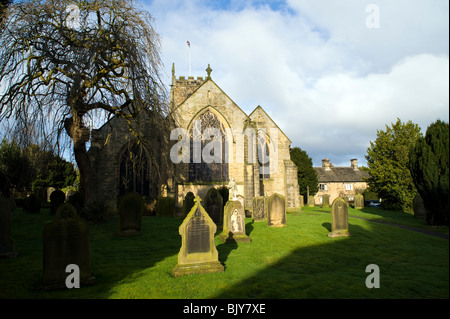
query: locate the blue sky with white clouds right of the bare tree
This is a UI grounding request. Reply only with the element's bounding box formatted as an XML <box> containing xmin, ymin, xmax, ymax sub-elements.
<box><xmin>144</xmin><ymin>0</ymin><xmax>449</xmax><ymax>166</ymax></box>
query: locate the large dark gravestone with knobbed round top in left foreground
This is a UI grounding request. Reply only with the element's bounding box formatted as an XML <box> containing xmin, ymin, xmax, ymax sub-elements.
<box><xmin>42</xmin><ymin>203</ymin><xmax>95</xmax><ymax>290</ymax></box>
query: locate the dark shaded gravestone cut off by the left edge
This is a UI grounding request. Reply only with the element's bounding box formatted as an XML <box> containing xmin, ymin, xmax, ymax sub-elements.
<box><xmin>0</xmin><ymin>195</ymin><xmax>17</xmax><ymax>258</ymax></box>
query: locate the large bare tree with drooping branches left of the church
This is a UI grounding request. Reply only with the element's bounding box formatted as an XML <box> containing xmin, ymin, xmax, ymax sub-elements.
<box><xmin>0</xmin><ymin>0</ymin><xmax>167</xmax><ymax>208</ymax></box>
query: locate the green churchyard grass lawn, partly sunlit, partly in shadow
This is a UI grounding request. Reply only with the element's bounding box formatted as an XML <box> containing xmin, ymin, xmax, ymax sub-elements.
<box><xmin>0</xmin><ymin>207</ymin><xmax>449</xmax><ymax>299</ymax></box>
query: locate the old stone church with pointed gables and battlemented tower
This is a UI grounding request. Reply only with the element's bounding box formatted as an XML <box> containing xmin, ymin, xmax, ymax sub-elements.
<box><xmin>88</xmin><ymin>65</ymin><xmax>300</xmax><ymax>211</ymax></box>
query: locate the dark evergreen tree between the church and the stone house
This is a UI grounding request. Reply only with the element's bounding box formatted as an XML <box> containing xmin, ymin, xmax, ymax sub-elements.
<box><xmin>290</xmin><ymin>147</ymin><xmax>319</xmax><ymax>199</ymax></box>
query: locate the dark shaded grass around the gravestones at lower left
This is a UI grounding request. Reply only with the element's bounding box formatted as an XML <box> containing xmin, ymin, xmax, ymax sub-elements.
<box><xmin>0</xmin><ymin>210</ymin><xmax>182</xmax><ymax>299</ymax></box>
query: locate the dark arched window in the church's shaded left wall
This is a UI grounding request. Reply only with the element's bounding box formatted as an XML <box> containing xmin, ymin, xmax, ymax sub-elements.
<box><xmin>119</xmin><ymin>144</ymin><xmax>150</xmax><ymax>196</ymax></box>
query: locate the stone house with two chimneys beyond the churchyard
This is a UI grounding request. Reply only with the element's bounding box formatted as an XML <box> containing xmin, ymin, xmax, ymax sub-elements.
<box><xmin>314</xmin><ymin>158</ymin><xmax>369</xmax><ymax>205</ymax></box>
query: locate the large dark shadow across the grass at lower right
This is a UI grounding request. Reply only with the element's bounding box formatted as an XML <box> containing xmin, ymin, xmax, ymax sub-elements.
<box><xmin>212</xmin><ymin>222</ymin><xmax>448</xmax><ymax>299</ymax></box>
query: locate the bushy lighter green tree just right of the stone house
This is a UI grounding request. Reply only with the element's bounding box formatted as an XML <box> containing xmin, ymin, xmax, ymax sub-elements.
<box><xmin>366</xmin><ymin>119</ymin><xmax>422</xmax><ymax>212</ymax></box>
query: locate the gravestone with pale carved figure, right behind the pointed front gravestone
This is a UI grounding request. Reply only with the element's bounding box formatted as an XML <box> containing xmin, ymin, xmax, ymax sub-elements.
<box><xmin>219</xmin><ymin>200</ymin><xmax>251</xmax><ymax>243</ymax></box>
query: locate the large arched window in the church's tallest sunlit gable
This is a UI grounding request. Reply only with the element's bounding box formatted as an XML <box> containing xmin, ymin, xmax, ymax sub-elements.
<box><xmin>189</xmin><ymin>110</ymin><xmax>228</xmax><ymax>182</ymax></box>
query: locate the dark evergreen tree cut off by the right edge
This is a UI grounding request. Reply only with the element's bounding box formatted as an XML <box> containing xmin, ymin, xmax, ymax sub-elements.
<box><xmin>409</xmin><ymin>120</ymin><xmax>450</xmax><ymax>225</ymax></box>
